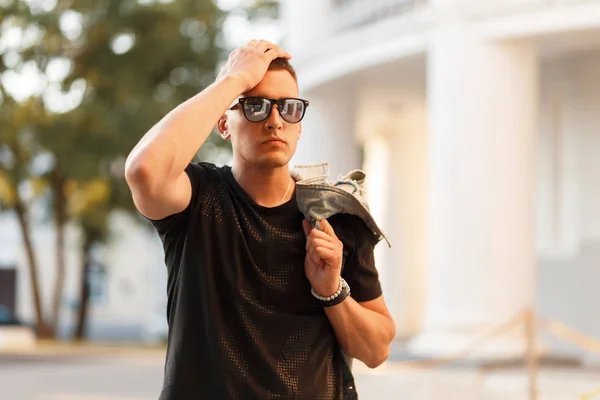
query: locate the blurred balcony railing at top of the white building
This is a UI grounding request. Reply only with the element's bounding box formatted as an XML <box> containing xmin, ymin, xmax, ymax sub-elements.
<box><xmin>332</xmin><ymin>0</ymin><xmax>427</xmax><ymax>32</ymax></box>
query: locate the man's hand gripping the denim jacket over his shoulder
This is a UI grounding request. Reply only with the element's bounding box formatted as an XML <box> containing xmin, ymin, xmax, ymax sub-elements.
<box><xmin>302</xmin><ymin>219</ymin><xmax>344</xmax><ymax>296</ymax></box>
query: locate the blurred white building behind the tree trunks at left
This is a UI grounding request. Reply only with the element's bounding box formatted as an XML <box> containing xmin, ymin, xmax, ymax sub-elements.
<box><xmin>0</xmin><ymin>213</ymin><xmax>167</xmax><ymax>347</ymax></box>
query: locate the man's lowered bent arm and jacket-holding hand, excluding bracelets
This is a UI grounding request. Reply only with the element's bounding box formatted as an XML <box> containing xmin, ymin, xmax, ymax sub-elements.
<box><xmin>303</xmin><ymin>219</ymin><xmax>396</xmax><ymax>368</ymax></box>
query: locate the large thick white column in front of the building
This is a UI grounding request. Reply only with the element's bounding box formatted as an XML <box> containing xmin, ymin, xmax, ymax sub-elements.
<box><xmin>410</xmin><ymin>22</ymin><xmax>538</xmax><ymax>358</ymax></box>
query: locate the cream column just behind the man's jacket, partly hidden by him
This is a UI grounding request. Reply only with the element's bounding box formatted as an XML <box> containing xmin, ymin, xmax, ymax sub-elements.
<box><xmin>357</xmin><ymin>86</ymin><xmax>427</xmax><ymax>339</ymax></box>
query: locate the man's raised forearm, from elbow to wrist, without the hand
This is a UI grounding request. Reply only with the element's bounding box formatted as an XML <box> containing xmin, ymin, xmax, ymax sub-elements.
<box><xmin>126</xmin><ymin>77</ymin><xmax>242</xmax><ymax>189</ymax></box>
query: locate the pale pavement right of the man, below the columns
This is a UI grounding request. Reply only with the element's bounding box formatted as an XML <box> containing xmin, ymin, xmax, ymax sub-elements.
<box><xmin>354</xmin><ymin>362</ymin><xmax>600</xmax><ymax>400</ymax></box>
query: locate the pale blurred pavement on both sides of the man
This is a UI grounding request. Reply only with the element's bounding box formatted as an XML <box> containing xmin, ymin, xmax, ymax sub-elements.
<box><xmin>0</xmin><ymin>343</ymin><xmax>600</xmax><ymax>400</ymax></box>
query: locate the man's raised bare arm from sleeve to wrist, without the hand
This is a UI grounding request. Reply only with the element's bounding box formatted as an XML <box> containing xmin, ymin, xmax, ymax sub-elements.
<box><xmin>125</xmin><ymin>77</ymin><xmax>241</xmax><ymax>220</ymax></box>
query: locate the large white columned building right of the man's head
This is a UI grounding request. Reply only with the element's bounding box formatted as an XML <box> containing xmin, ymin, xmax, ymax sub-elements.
<box><xmin>282</xmin><ymin>0</ymin><xmax>600</xmax><ymax>361</ymax></box>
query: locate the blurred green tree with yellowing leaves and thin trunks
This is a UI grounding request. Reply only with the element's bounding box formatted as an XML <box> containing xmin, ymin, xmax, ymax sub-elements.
<box><xmin>0</xmin><ymin>0</ymin><xmax>237</xmax><ymax>337</ymax></box>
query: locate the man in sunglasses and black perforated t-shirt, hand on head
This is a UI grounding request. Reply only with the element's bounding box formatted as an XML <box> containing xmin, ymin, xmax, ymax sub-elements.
<box><xmin>125</xmin><ymin>40</ymin><xmax>395</xmax><ymax>400</ymax></box>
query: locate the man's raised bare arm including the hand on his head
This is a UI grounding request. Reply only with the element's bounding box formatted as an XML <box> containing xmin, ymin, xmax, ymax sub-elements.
<box><xmin>125</xmin><ymin>40</ymin><xmax>291</xmax><ymax>219</ymax></box>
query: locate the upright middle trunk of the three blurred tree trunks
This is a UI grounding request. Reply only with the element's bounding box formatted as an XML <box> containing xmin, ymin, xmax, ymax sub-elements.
<box><xmin>52</xmin><ymin>168</ymin><xmax>66</xmax><ymax>329</ymax></box>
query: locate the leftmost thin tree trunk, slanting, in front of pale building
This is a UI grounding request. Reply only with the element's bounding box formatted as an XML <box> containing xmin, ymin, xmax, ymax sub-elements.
<box><xmin>15</xmin><ymin>194</ymin><xmax>54</xmax><ymax>338</ymax></box>
